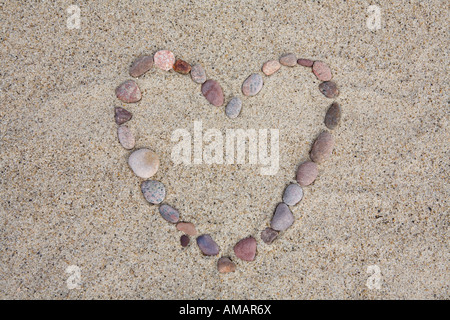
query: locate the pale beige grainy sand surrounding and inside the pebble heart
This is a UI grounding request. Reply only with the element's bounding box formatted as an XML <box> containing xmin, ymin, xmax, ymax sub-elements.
<box><xmin>0</xmin><ymin>0</ymin><xmax>450</xmax><ymax>299</ymax></box>
